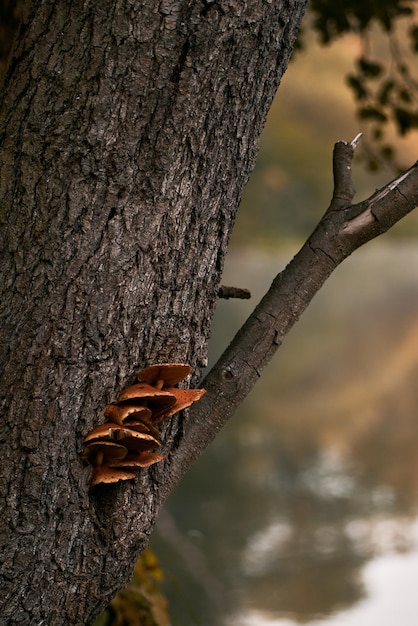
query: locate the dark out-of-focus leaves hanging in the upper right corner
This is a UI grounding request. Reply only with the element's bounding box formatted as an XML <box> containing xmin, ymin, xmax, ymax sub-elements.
<box><xmin>302</xmin><ymin>0</ymin><xmax>418</xmax><ymax>169</ymax></box>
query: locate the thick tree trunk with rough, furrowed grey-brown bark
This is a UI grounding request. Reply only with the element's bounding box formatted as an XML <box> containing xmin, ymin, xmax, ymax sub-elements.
<box><xmin>0</xmin><ymin>0</ymin><xmax>306</xmax><ymax>625</ymax></box>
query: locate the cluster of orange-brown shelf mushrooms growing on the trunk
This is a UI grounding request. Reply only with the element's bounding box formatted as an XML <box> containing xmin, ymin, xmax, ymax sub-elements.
<box><xmin>82</xmin><ymin>363</ymin><xmax>205</xmax><ymax>486</ymax></box>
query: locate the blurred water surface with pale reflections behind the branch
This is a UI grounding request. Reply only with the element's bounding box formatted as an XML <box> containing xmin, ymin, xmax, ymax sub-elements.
<box><xmin>153</xmin><ymin>239</ymin><xmax>418</xmax><ymax>626</ymax></box>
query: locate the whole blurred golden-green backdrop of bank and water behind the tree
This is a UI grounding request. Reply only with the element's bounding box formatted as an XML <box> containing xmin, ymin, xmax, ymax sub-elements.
<box><xmin>151</xmin><ymin>11</ymin><xmax>418</xmax><ymax>626</ymax></box>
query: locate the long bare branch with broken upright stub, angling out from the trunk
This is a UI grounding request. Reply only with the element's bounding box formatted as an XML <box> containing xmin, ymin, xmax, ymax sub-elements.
<box><xmin>166</xmin><ymin>136</ymin><xmax>418</xmax><ymax>492</ymax></box>
